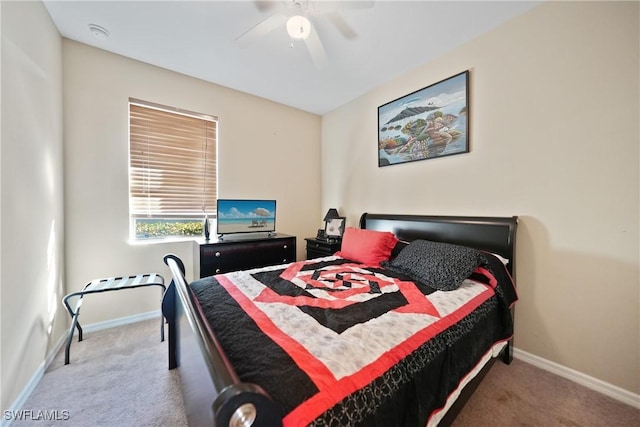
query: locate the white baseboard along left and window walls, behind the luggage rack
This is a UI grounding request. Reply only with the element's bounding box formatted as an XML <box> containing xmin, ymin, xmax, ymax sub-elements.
<box><xmin>0</xmin><ymin>310</ymin><xmax>161</xmax><ymax>427</ymax></box>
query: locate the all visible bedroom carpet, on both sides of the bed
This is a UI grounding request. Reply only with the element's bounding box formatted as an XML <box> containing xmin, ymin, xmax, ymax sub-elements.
<box><xmin>12</xmin><ymin>320</ymin><xmax>640</xmax><ymax>427</ymax></box>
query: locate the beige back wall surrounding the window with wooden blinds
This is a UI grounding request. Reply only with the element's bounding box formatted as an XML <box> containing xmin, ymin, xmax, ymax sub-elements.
<box><xmin>63</xmin><ymin>39</ymin><xmax>322</xmax><ymax>323</ymax></box>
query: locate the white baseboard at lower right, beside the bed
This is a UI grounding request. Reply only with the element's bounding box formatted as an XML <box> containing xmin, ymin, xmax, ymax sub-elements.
<box><xmin>513</xmin><ymin>348</ymin><xmax>640</xmax><ymax>409</ymax></box>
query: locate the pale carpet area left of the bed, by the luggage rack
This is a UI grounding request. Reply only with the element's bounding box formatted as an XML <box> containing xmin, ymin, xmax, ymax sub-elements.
<box><xmin>11</xmin><ymin>319</ymin><xmax>186</xmax><ymax>427</ymax></box>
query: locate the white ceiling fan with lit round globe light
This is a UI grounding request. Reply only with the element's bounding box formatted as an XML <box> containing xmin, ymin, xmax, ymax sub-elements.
<box><xmin>235</xmin><ymin>0</ymin><xmax>374</xmax><ymax>68</ymax></box>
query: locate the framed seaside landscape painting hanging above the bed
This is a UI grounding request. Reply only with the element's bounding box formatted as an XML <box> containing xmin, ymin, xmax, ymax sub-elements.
<box><xmin>378</xmin><ymin>70</ymin><xmax>469</xmax><ymax>166</ymax></box>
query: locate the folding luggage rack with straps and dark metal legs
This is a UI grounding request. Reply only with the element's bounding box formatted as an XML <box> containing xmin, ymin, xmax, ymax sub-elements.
<box><xmin>62</xmin><ymin>273</ymin><xmax>166</xmax><ymax>365</ymax></box>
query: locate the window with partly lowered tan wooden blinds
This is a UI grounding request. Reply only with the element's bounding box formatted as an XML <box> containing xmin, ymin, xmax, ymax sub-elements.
<box><xmin>129</xmin><ymin>99</ymin><xmax>218</xmax><ymax>240</ymax></box>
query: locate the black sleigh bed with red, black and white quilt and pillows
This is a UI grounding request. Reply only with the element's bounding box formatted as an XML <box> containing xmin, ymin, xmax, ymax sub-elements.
<box><xmin>162</xmin><ymin>213</ymin><xmax>517</xmax><ymax>427</ymax></box>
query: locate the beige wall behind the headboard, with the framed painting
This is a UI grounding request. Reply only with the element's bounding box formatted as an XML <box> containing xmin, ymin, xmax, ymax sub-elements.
<box><xmin>322</xmin><ymin>2</ymin><xmax>640</xmax><ymax>393</ymax></box>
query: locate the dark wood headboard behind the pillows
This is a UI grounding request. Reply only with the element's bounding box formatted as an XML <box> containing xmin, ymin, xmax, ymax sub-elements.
<box><xmin>360</xmin><ymin>213</ymin><xmax>518</xmax><ymax>280</ymax></box>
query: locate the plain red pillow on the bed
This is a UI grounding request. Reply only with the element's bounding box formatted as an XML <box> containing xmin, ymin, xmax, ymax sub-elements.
<box><xmin>336</xmin><ymin>227</ymin><xmax>398</xmax><ymax>266</ymax></box>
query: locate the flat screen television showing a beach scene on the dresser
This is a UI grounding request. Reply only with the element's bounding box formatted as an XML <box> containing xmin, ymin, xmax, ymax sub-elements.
<box><xmin>216</xmin><ymin>199</ymin><xmax>276</xmax><ymax>236</ymax></box>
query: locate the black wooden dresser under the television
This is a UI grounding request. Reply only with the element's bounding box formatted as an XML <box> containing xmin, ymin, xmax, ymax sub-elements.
<box><xmin>200</xmin><ymin>233</ymin><xmax>296</xmax><ymax>277</ymax></box>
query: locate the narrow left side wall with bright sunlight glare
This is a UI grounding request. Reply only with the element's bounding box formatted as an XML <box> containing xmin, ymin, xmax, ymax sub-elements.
<box><xmin>0</xmin><ymin>1</ymin><xmax>66</xmax><ymax>410</ymax></box>
